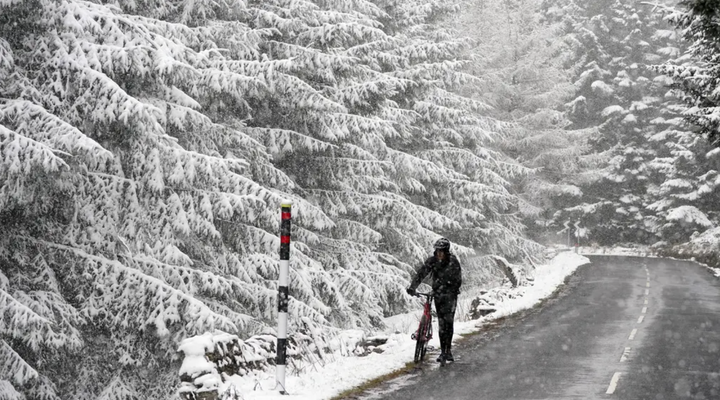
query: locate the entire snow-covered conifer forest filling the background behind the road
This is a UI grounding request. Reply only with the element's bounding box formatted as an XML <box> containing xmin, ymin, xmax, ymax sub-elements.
<box><xmin>0</xmin><ymin>0</ymin><xmax>720</xmax><ymax>400</ymax></box>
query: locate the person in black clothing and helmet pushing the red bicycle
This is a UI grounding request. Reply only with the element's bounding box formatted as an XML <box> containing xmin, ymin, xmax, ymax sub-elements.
<box><xmin>407</xmin><ymin>238</ymin><xmax>462</xmax><ymax>362</ymax></box>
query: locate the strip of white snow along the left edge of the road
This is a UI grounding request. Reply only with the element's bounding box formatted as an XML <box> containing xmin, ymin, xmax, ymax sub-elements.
<box><xmin>179</xmin><ymin>251</ymin><xmax>589</xmax><ymax>400</ymax></box>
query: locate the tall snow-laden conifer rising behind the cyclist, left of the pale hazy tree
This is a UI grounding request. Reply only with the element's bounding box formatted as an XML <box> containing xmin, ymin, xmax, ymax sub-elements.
<box><xmin>366</xmin><ymin>2</ymin><xmax>539</xmax><ymax>283</ymax></box>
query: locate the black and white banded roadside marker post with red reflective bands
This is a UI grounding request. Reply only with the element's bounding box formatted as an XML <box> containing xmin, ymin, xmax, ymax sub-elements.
<box><xmin>275</xmin><ymin>200</ymin><xmax>292</xmax><ymax>394</ymax></box>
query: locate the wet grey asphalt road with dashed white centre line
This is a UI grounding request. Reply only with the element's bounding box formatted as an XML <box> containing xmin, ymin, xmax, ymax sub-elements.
<box><xmin>360</xmin><ymin>256</ymin><xmax>720</xmax><ymax>400</ymax></box>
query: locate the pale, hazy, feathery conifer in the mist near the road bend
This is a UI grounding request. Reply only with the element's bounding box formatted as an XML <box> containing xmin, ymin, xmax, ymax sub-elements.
<box><xmin>462</xmin><ymin>0</ymin><xmax>592</xmax><ymax>241</ymax></box>
